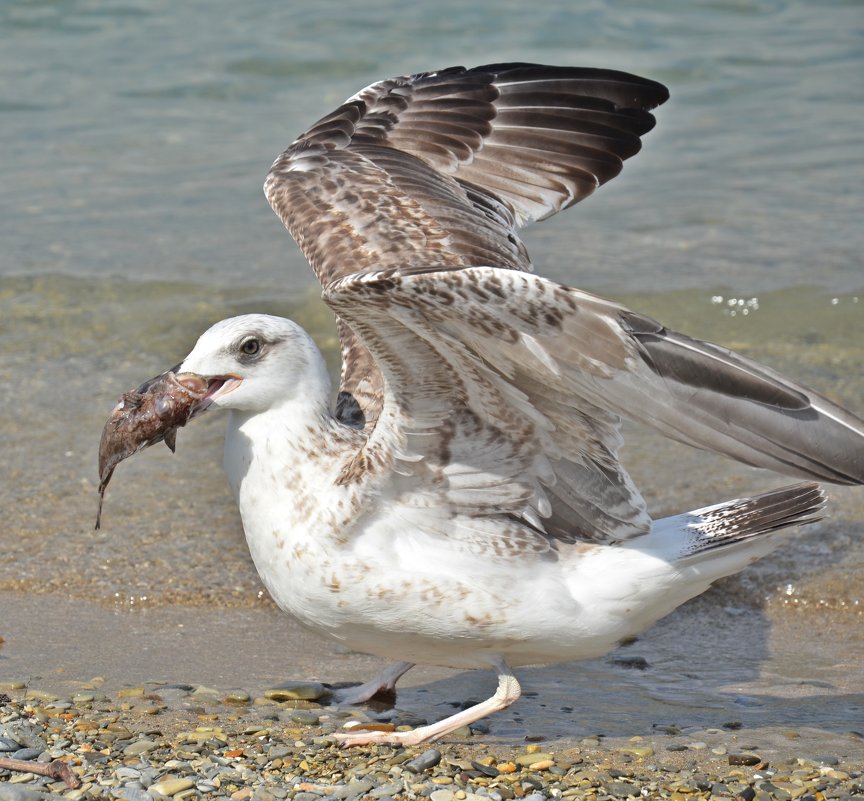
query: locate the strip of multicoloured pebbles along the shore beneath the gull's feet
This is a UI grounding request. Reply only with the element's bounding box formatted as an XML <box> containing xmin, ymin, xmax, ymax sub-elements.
<box><xmin>0</xmin><ymin>683</ymin><xmax>864</xmax><ymax>801</ymax></box>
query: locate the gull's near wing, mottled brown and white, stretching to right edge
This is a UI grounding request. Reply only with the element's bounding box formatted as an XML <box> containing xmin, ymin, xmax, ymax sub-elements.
<box><xmin>324</xmin><ymin>267</ymin><xmax>864</xmax><ymax>541</ymax></box>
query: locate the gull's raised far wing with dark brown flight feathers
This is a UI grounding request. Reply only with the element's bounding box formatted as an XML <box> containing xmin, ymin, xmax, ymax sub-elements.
<box><xmin>264</xmin><ymin>64</ymin><xmax>668</xmax><ymax>424</ymax></box>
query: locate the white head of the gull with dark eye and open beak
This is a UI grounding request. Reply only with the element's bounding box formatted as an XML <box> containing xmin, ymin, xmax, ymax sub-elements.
<box><xmin>177</xmin><ymin>314</ymin><xmax>329</xmax><ymax>414</ymax></box>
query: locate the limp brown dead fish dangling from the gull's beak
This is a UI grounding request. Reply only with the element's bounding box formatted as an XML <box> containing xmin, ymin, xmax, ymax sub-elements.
<box><xmin>96</xmin><ymin>364</ymin><xmax>207</xmax><ymax>529</ymax></box>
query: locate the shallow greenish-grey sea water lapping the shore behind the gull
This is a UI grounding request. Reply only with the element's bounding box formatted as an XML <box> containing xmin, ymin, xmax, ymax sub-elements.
<box><xmin>0</xmin><ymin>0</ymin><xmax>864</xmax><ymax>729</ymax></box>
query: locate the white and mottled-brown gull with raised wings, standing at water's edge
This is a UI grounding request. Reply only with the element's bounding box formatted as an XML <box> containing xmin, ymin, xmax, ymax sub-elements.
<box><xmin>135</xmin><ymin>64</ymin><xmax>864</xmax><ymax>746</ymax></box>
